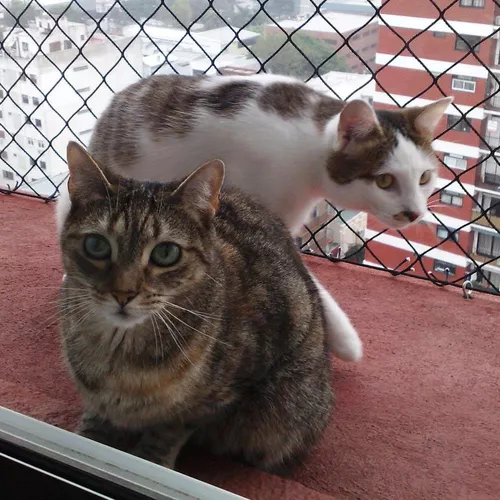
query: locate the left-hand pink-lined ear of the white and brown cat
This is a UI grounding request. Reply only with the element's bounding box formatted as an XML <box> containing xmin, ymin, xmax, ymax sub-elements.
<box><xmin>338</xmin><ymin>99</ymin><xmax>381</xmax><ymax>150</ymax></box>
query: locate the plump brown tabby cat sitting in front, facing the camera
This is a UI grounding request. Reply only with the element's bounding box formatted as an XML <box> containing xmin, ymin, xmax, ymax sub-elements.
<box><xmin>61</xmin><ymin>143</ymin><xmax>333</xmax><ymax>472</ymax></box>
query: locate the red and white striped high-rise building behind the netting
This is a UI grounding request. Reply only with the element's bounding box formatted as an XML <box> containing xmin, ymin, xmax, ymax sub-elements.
<box><xmin>365</xmin><ymin>0</ymin><xmax>500</xmax><ymax>286</ymax></box>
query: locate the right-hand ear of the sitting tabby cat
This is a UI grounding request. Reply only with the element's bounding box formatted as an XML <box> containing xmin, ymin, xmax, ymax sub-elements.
<box><xmin>173</xmin><ymin>160</ymin><xmax>225</xmax><ymax>223</ymax></box>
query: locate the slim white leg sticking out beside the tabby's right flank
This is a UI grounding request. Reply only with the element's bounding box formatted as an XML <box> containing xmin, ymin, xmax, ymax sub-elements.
<box><xmin>311</xmin><ymin>275</ymin><xmax>363</xmax><ymax>361</ymax></box>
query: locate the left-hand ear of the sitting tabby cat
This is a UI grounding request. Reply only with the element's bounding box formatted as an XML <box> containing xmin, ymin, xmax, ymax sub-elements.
<box><xmin>66</xmin><ymin>141</ymin><xmax>114</xmax><ymax>201</ymax></box>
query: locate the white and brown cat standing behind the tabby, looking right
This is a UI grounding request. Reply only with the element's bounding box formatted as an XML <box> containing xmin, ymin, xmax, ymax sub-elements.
<box><xmin>57</xmin><ymin>74</ymin><xmax>452</xmax><ymax>361</ymax></box>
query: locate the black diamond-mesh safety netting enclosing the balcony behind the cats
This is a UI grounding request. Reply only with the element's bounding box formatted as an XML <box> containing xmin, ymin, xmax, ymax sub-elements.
<box><xmin>0</xmin><ymin>0</ymin><xmax>500</xmax><ymax>292</ymax></box>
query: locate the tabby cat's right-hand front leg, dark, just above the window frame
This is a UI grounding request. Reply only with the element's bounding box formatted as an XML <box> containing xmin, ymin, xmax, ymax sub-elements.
<box><xmin>130</xmin><ymin>424</ymin><xmax>194</xmax><ymax>469</ymax></box>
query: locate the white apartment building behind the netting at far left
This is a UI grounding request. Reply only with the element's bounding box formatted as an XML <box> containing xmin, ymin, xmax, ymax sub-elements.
<box><xmin>0</xmin><ymin>16</ymin><xmax>142</xmax><ymax>195</ymax></box>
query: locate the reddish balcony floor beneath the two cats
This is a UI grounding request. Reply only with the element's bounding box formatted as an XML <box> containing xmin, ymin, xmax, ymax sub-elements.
<box><xmin>0</xmin><ymin>196</ymin><xmax>500</xmax><ymax>500</ymax></box>
